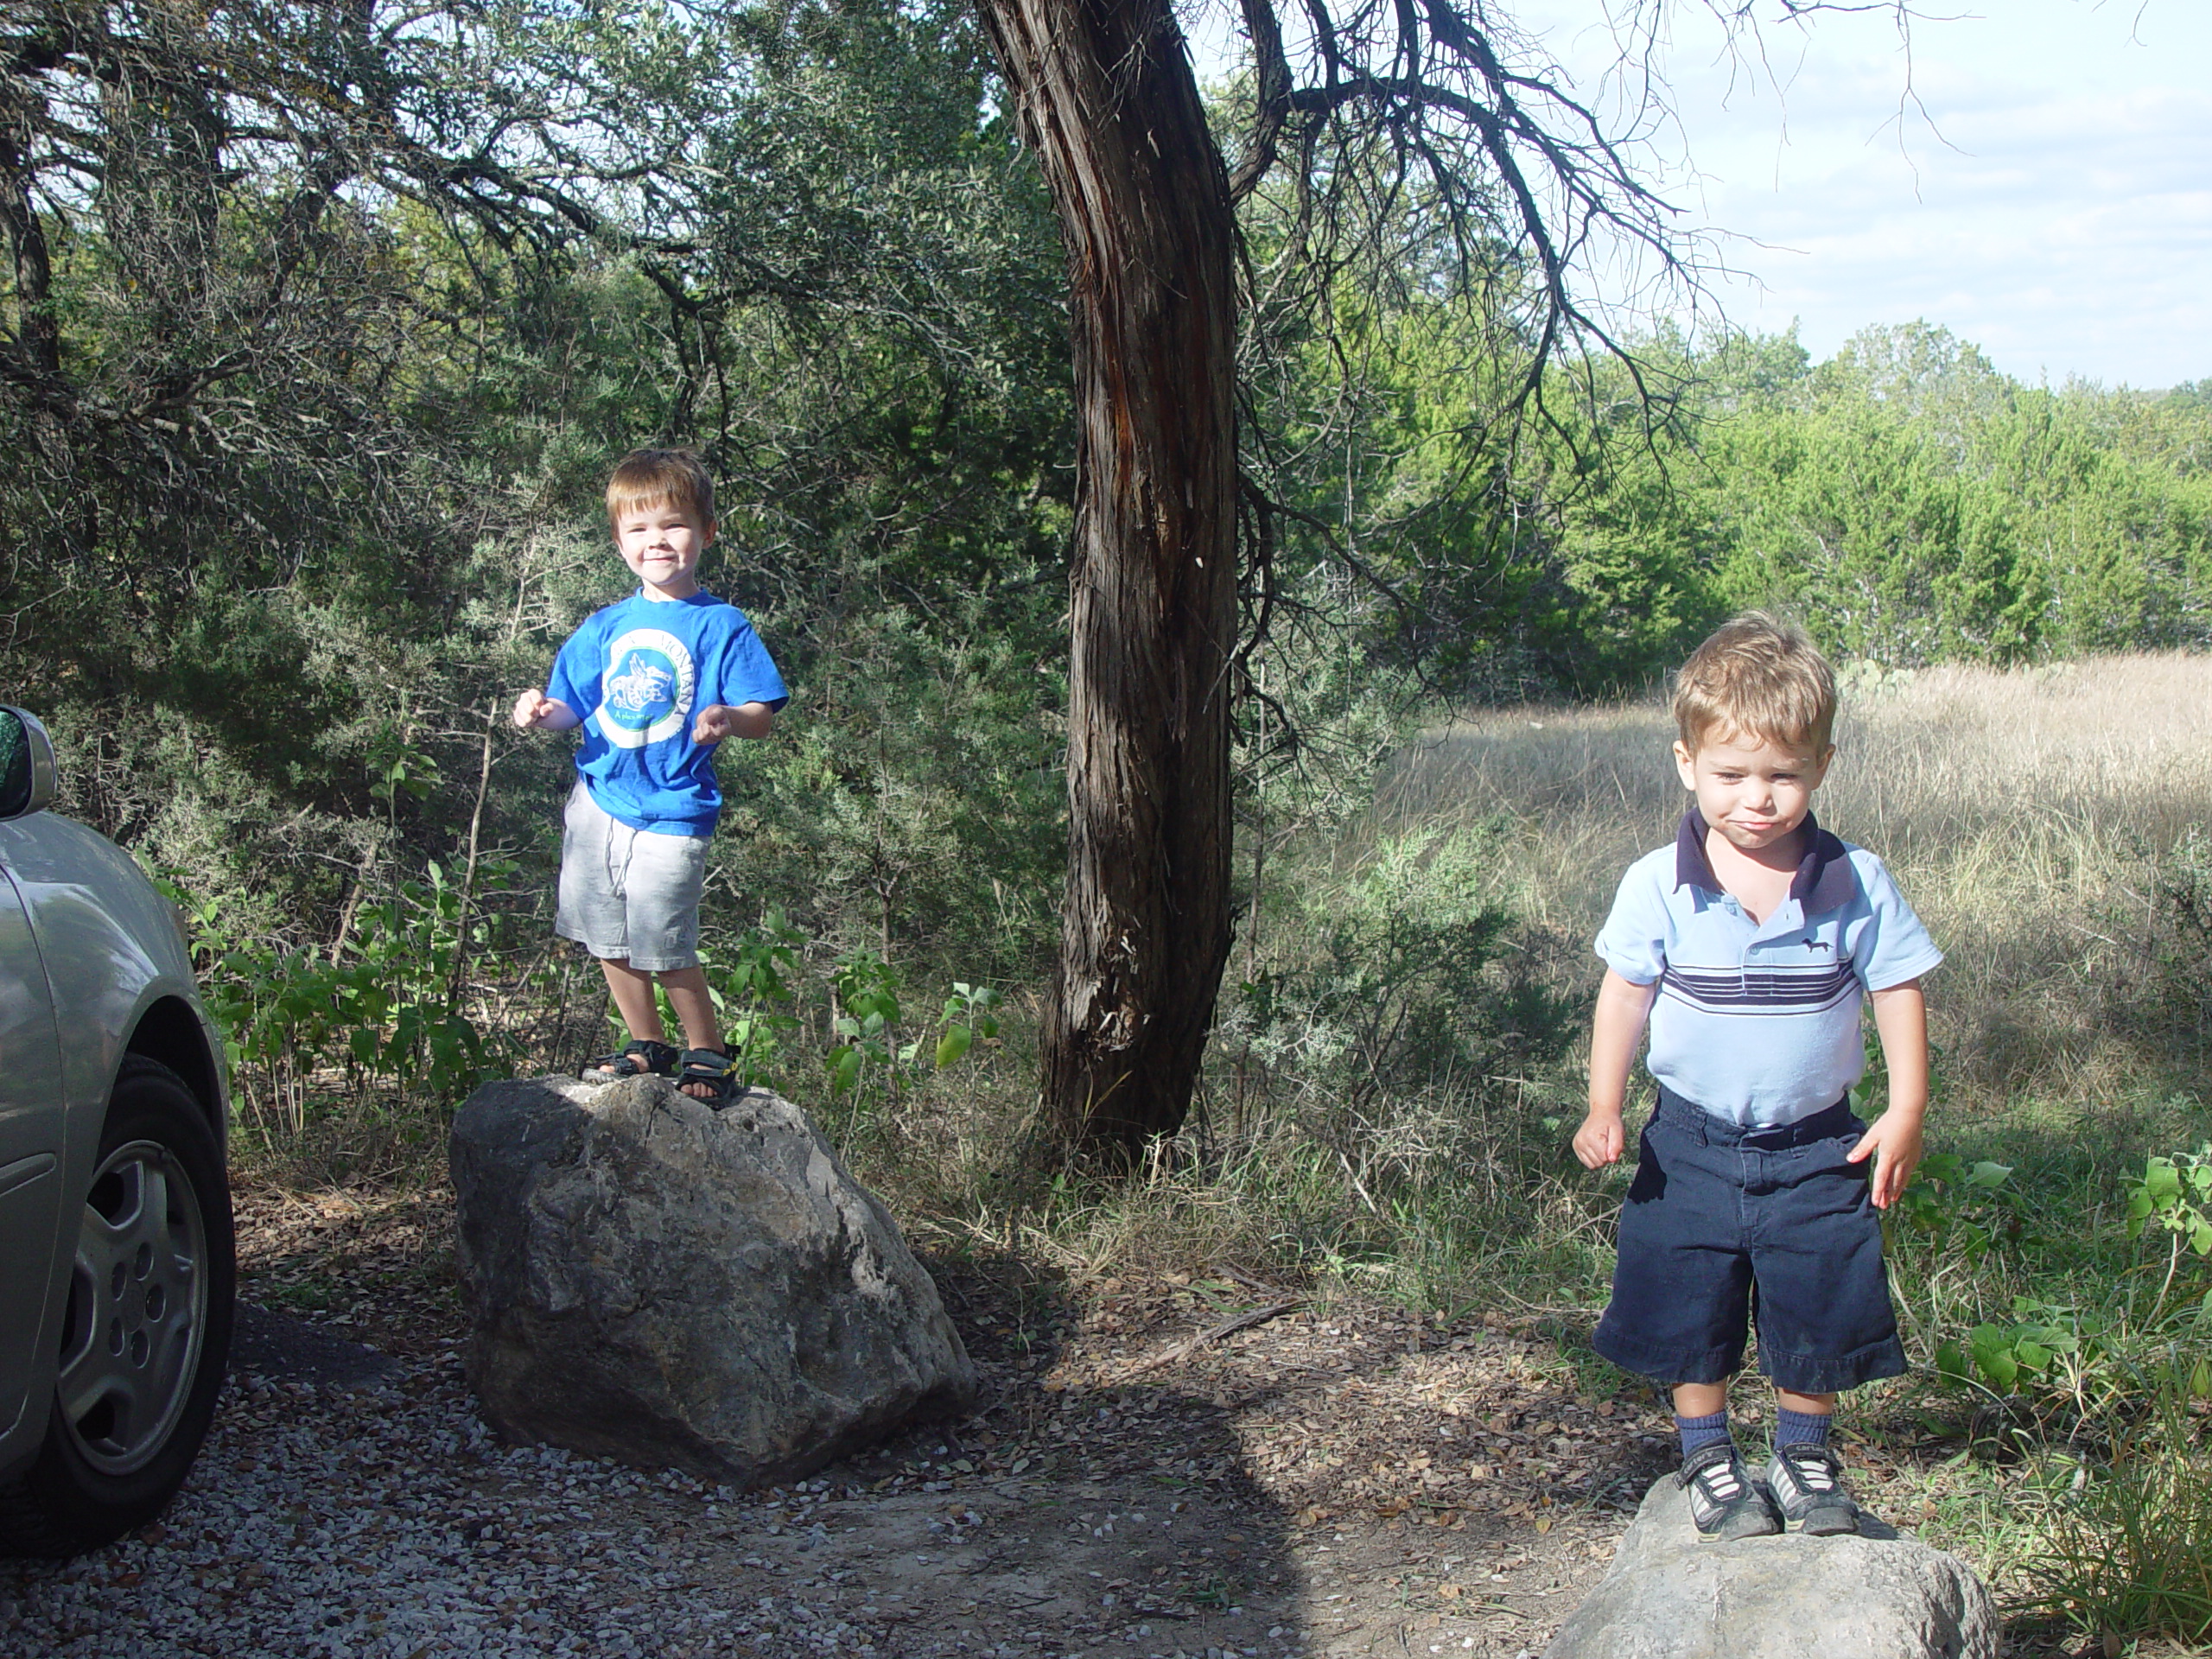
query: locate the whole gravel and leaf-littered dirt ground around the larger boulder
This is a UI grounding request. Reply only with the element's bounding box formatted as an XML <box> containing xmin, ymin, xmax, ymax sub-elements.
<box><xmin>0</xmin><ymin>1190</ymin><xmax>1707</xmax><ymax>1659</ymax></box>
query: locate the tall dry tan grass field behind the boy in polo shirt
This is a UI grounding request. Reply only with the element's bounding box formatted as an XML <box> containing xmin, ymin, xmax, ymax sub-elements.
<box><xmin>1367</xmin><ymin>655</ymin><xmax>2212</xmax><ymax>1102</ymax></box>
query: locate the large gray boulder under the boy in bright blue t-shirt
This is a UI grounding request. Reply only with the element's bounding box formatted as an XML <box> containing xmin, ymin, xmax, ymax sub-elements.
<box><xmin>451</xmin><ymin>1077</ymin><xmax>976</xmax><ymax>1484</ymax></box>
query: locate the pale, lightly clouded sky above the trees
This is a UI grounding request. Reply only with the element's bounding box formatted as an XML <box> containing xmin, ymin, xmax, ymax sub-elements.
<box><xmin>1201</xmin><ymin>0</ymin><xmax>2212</xmax><ymax>387</ymax></box>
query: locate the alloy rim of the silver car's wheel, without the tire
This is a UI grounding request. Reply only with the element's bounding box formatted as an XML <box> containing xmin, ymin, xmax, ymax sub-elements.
<box><xmin>55</xmin><ymin>1141</ymin><xmax>208</xmax><ymax>1476</ymax></box>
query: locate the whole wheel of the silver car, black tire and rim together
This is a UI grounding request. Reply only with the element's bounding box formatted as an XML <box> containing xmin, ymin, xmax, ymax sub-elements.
<box><xmin>0</xmin><ymin>1055</ymin><xmax>237</xmax><ymax>1555</ymax></box>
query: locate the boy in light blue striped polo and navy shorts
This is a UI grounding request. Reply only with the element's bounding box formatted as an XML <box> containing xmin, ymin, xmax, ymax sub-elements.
<box><xmin>1575</xmin><ymin>613</ymin><xmax>1942</xmax><ymax>1540</ymax></box>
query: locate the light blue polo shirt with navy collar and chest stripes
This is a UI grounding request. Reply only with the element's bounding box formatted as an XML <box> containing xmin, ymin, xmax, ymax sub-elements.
<box><xmin>1597</xmin><ymin>807</ymin><xmax>1942</xmax><ymax>1128</ymax></box>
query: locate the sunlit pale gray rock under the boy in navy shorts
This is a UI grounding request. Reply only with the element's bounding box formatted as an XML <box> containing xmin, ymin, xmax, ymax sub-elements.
<box><xmin>1544</xmin><ymin>1476</ymin><xmax>1999</xmax><ymax>1659</ymax></box>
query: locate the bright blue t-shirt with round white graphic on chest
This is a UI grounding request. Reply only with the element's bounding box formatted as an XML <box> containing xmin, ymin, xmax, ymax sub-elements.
<box><xmin>546</xmin><ymin>593</ymin><xmax>790</xmax><ymax>836</ymax></box>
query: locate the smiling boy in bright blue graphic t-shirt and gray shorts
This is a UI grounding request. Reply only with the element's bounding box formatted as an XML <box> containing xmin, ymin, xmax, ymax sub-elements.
<box><xmin>515</xmin><ymin>449</ymin><xmax>790</xmax><ymax>1106</ymax></box>
